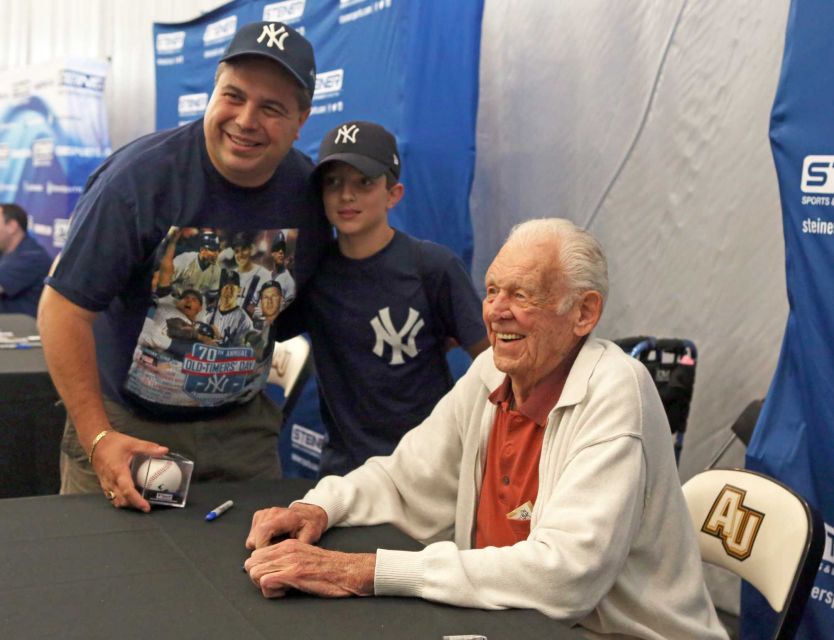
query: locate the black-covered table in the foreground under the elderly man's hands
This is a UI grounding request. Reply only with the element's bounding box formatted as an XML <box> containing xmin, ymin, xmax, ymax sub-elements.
<box><xmin>0</xmin><ymin>480</ymin><xmax>579</xmax><ymax>640</ymax></box>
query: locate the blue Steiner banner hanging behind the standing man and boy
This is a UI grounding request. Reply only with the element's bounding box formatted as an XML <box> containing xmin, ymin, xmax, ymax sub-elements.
<box><xmin>154</xmin><ymin>0</ymin><xmax>483</xmax><ymax>477</ymax></box>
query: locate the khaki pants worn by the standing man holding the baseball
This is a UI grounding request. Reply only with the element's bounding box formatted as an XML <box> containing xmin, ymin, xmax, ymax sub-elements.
<box><xmin>61</xmin><ymin>393</ymin><xmax>281</xmax><ymax>494</ymax></box>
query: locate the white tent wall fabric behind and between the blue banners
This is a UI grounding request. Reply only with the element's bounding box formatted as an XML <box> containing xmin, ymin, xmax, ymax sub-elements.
<box><xmin>0</xmin><ymin>0</ymin><xmax>789</xmax><ymax>609</ymax></box>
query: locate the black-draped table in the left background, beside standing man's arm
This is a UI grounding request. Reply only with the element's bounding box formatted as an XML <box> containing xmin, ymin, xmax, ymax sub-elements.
<box><xmin>0</xmin><ymin>314</ymin><xmax>66</xmax><ymax>498</ymax></box>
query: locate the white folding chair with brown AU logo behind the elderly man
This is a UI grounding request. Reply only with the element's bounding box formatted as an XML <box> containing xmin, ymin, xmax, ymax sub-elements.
<box><xmin>683</xmin><ymin>469</ymin><xmax>825</xmax><ymax>640</ymax></box>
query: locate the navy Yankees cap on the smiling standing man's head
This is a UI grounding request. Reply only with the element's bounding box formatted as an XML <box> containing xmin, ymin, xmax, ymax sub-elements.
<box><xmin>220</xmin><ymin>22</ymin><xmax>316</xmax><ymax>97</ymax></box>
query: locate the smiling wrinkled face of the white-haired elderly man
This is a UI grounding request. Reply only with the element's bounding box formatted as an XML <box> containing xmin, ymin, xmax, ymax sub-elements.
<box><xmin>483</xmin><ymin>242</ymin><xmax>593</xmax><ymax>400</ymax></box>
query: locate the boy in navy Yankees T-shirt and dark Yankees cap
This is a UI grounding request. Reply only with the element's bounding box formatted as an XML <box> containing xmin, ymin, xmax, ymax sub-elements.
<box><xmin>276</xmin><ymin>122</ymin><xmax>487</xmax><ymax>476</ymax></box>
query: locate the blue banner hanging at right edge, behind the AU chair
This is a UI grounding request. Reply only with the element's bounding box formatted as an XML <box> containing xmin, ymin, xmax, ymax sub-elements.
<box><xmin>741</xmin><ymin>0</ymin><xmax>834</xmax><ymax>640</ymax></box>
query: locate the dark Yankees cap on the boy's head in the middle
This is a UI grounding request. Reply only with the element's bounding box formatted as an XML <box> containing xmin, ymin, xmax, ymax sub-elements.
<box><xmin>315</xmin><ymin>120</ymin><xmax>400</xmax><ymax>180</ymax></box>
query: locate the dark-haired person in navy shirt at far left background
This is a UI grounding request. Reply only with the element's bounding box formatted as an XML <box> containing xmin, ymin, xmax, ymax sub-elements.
<box><xmin>0</xmin><ymin>203</ymin><xmax>52</xmax><ymax>317</ymax></box>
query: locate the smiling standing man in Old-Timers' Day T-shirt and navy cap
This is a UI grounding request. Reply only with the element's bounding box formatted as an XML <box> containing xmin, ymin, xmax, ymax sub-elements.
<box><xmin>39</xmin><ymin>22</ymin><xmax>331</xmax><ymax>511</ymax></box>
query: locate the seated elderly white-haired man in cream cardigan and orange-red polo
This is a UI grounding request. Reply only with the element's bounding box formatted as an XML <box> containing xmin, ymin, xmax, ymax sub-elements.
<box><xmin>244</xmin><ymin>219</ymin><xmax>727</xmax><ymax>640</ymax></box>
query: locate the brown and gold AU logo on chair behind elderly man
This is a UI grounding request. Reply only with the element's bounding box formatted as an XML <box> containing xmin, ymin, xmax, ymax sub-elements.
<box><xmin>701</xmin><ymin>484</ymin><xmax>765</xmax><ymax>560</ymax></box>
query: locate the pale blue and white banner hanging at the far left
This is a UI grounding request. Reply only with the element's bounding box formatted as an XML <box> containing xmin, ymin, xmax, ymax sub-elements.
<box><xmin>0</xmin><ymin>60</ymin><xmax>110</xmax><ymax>256</ymax></box>
